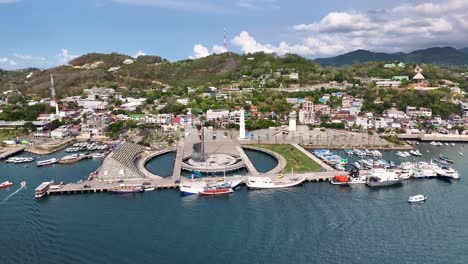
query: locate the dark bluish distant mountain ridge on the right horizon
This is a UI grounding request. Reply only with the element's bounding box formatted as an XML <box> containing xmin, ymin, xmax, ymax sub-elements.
<box><xmin>315</xmin><ymin>47</ymin><xmax>468</xmax><ymax>67</ymax></box>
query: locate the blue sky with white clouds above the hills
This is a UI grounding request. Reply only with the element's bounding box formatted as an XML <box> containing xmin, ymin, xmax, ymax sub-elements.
<box><xmin>0</xmin><ymin>0</ymin><xmax>468</xmax><ymax>69</ymax></box>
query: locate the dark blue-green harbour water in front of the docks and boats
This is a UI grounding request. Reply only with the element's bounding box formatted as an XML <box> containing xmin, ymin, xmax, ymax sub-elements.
<box><xmin>0</xmin><ymin>145</ymin><xmax>468</xmax><ymax>264</ymax></box>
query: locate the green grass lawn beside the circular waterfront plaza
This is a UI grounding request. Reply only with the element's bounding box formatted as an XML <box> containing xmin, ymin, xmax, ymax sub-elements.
<box><xmin>255</xmin><ymin>145</ymin><xmax>324</xmax><ymax>173</ymax></box>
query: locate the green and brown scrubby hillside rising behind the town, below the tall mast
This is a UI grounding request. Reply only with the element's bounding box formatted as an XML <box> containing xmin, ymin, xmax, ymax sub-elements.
<box><xmin>0</xmin><ymin>53</ymin><xmax>323</xmax><ymax>96</ymax></box>
